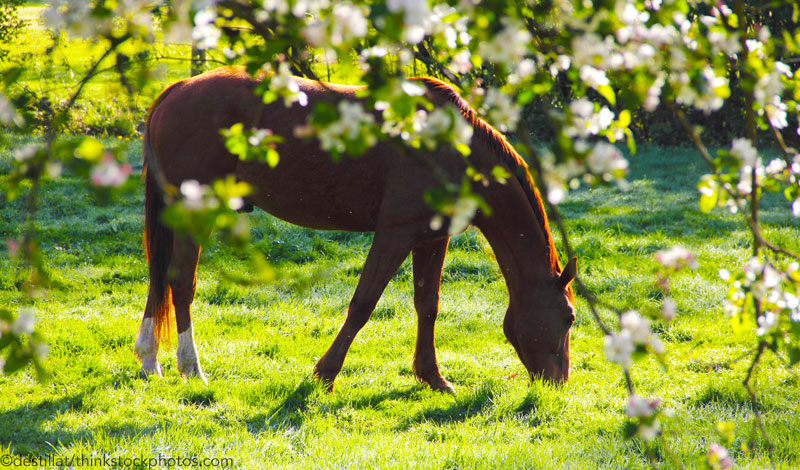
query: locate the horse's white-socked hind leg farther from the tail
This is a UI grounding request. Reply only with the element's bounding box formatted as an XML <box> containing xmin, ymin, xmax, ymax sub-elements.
<box><xmin>169</xmin><ymin>236</ymin><xmax>208</xmax><ymax>383</ymax></box>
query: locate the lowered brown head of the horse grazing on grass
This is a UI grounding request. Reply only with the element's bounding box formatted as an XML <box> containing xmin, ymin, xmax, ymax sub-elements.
<box><xmin>503</xmin><ymin>258</ymin><xmax>576</xmax><ymax>383</ymax></box>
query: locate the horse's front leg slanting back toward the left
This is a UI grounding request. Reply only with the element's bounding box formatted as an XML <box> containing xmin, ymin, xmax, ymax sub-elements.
<box><xmin>314</xmin><ymin>229</ymin><xmax>412</xmax><ymax>390</ymax></box>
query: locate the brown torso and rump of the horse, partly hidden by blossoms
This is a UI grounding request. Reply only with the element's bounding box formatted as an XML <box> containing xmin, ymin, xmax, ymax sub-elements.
<box><xmin>148</xmin><ymin>68</ymin><xmax>444</xmax><ymax>231</ymax></box>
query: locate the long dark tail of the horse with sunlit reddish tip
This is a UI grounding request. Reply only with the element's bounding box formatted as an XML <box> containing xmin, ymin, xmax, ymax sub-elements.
<box><xmin>142</xmin><ymin>95</ymin><xmax>174</xmax><ymax>344</ymax></box>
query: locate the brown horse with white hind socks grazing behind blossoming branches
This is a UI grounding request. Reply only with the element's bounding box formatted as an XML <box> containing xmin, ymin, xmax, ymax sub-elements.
<box><xmin>135</xmin><ymin>68</ymin><xmax>575</xmax><ymax>391</ymax></box>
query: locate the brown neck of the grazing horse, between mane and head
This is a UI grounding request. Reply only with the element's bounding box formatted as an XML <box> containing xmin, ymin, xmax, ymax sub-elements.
<box><xmin>476</xmin><ymin>179</ymin><xmax>557</xmax><ymax>298</ymax></box>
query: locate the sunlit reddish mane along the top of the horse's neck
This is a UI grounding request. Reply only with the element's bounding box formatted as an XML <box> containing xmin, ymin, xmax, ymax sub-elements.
<box><xmin>414</xmin><ymin>78</ymin><xmax>561</xmax><ymax>272</ymax></box>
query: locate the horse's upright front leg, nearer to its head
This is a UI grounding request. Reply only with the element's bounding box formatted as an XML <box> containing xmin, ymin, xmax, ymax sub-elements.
<box><xmin>411</xmin><ymin>238</ymin><xmax>453</xmax><ymax>393</ymax></box>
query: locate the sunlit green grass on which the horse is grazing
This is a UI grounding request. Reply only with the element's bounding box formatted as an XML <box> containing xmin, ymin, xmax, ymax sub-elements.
<box><xmin>0</xmin><ymin>131</ymin><xmax>800</xmax><ymax>468</ymax></box>
